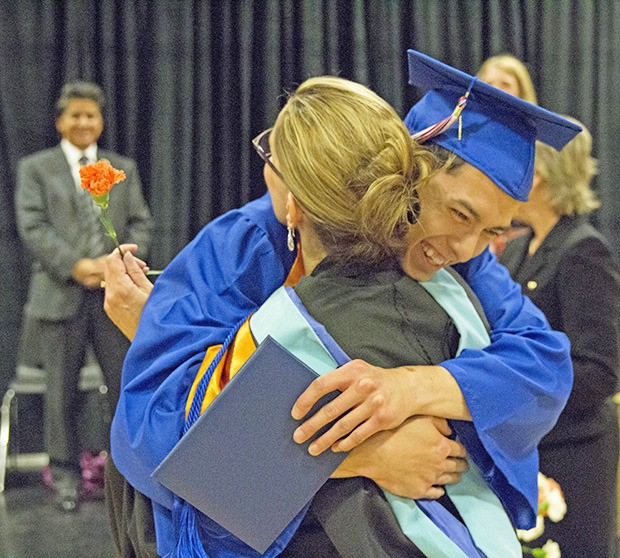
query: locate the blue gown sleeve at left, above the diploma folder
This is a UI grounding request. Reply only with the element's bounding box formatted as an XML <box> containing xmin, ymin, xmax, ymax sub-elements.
<box><xmin>111</xmin><ymin>195</ymin><xmax>295</xmax><ymax>509</ymax></box>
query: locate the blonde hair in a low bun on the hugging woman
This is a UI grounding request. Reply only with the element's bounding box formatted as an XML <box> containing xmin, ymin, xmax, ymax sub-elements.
<box><xmin>272</xmin><ymin>77</ymin><xmax>435</xmax><ymax>261</ymax></box>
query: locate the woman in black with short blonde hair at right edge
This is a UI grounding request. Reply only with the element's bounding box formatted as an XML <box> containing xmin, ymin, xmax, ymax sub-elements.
<box><xmin>501</xmin><ymin>117</ymin><xmax>620</xmax><ymax>558</ymax></box>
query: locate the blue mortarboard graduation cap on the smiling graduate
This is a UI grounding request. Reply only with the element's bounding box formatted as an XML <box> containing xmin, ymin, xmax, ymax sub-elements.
<box><xmin>405</xmin><ymin>50</ymin><xmax>581</xmax><ymax>201</ymax></box>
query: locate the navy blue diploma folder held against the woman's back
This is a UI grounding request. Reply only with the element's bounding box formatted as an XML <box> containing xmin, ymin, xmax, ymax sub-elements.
<box><xmin>153</xmin><ymin>337</ymin><xmax>346</xmax><ymax>553</ymax></box>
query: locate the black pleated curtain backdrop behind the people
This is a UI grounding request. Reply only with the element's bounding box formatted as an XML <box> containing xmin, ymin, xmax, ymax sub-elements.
<box><xmin>0</xmin><ymin>0</ymin><xmax>620</xmax><ymax>390</ymax></box>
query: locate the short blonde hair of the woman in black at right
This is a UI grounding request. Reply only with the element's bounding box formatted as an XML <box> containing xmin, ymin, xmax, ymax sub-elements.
<box><xmin>534</xmin><ymin>116</ymin><xmax>601</xmax><ymax>215</ymax></box>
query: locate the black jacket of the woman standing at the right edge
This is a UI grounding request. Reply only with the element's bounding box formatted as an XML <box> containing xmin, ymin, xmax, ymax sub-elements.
<box><xmin>500</xmin><ymin>216</ymin><xmax>620</xmax><ymax>447</ymax></box>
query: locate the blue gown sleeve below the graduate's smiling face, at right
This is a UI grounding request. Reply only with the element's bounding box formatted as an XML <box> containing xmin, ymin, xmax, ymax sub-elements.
<box><xmin>441</xmin><ymin>249</ymin><xmax>573</xmax><ymax>528</ymax></box>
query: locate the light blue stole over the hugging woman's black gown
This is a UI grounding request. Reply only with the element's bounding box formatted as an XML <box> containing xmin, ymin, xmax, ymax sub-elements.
<box><xmin>250</xmin><ymin>269</ymin><xmax>522</xmax><ymax>558</ymax></box>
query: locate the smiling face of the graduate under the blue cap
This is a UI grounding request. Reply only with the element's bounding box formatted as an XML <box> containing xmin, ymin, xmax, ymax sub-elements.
<box><xmin>402</xmin><ymin>163</ymin><xmax>521</xmax><ymax>281</ymax></box>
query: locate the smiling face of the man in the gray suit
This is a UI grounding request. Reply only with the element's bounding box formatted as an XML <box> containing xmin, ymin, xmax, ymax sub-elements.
<box><xmin>56</xmin><ymin>98</ymin><xmax>103</xmax><ymax>149</ymax></box>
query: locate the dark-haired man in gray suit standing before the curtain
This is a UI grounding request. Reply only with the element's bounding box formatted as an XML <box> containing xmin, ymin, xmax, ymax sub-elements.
<box><xmin>15</xmin><ymin>81</ymin><xmax>152</xmax><ymax>511</ymax></box>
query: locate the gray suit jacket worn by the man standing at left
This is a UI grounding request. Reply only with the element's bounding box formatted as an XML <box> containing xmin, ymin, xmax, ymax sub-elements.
<box><xmin>15</xmin><ymin>145</ymin><xmax>152</xmax><ymax>320</ymax></box>
